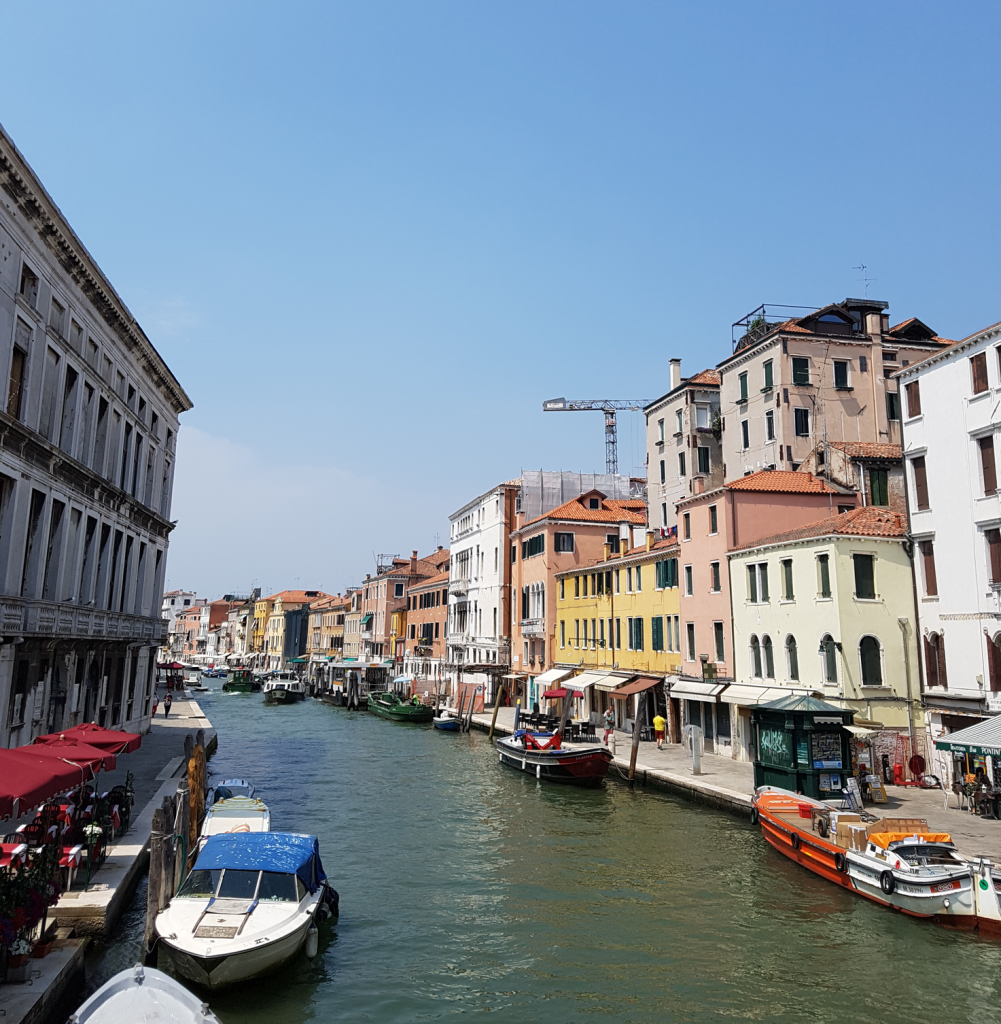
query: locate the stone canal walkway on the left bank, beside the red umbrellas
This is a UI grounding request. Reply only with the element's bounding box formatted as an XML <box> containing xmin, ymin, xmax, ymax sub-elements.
<box><xmin>6</xmin><ymin>695</ymin><xmax>218</xmax><ymax>1024</ymax></box>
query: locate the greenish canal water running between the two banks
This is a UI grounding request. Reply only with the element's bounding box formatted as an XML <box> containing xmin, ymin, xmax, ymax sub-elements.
<box><xmin>88</xmin><ymin>692</ymin><xmax>1001</xmax><ymax>1024</ymax></box>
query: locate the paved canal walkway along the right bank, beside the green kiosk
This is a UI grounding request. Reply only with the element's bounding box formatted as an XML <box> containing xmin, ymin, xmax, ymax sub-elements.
<box><xmin>473</xmin><ymin>708</ymin><xmax>1001</xmax><ymax>864</ymax></box>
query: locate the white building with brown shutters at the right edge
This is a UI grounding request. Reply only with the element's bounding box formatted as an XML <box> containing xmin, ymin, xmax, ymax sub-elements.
<box><xmin>897</xmin><ymin>325</ymin><xmax>1001</xmax><ymax>774</ymax></box>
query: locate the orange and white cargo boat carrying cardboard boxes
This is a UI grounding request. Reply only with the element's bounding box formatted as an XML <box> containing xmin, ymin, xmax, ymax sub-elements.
<box><xmin>751</xmin><ymin>785</ymin><xmax>1001</xmax><ymax>935</ymax></box>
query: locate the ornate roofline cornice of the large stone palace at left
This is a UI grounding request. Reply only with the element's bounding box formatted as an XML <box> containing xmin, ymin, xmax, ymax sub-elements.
<box><xmin>0</xmin><ymin>126</ymin><xmax>192</xmax><ymax>414</ymax></box>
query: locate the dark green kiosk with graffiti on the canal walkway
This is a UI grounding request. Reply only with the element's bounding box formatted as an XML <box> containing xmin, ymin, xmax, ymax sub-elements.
<box><xmin>750</xmin><ymin>693</ymin><xmax>855</xmax><ymax>800</ymax></box>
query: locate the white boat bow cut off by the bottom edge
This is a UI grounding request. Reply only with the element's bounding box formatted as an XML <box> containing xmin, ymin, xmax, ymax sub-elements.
<box><xmin>69</xmin><ymin>964</ymin><xmax>220</xmax><ymax>1024</ymax></box>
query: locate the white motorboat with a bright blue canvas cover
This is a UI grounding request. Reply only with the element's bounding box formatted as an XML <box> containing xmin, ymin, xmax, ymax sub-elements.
<box><xmin>157</xmin><ymin>833</ymin><xmax>338</xmax><ymax>988</ymax></box>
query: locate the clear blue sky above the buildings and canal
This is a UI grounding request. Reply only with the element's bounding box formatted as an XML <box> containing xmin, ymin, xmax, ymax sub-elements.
<box><xmin>0</xmin><ymin>0</ymin><xmax>1001</xmax><ymax>596</ymax></box>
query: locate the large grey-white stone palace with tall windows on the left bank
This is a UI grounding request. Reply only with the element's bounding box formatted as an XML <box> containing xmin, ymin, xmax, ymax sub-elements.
<box><xmin>0</xmin><ymin>129</ymin><xmax>191</xmax><ymax>746</ymax></box>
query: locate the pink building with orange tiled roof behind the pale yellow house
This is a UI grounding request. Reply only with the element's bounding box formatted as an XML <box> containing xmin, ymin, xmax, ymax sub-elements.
<box><xmin>670</xmin><ymin>470</ymin><xmax>858</xmax><ymax>754</ymax></box>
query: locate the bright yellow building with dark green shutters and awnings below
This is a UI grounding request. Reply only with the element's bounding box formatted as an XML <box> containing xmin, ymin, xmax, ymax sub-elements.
<box><xmin>554</xmin><ymin>534</ymin><xmax>682</xmax><ymax>725</ymax></box>
